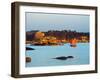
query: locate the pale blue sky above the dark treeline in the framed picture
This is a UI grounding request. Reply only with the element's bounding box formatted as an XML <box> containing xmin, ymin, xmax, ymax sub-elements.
<box><xmin>25</xmin><ymin>12</ymin><xmax>90</xmax><ymax>32</ymax></box>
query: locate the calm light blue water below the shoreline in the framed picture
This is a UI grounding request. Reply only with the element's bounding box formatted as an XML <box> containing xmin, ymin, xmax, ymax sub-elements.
<box><xmin>26</xmin><ymin>43</ymin><xmax>89</xmax><ymax>67</ymax></box>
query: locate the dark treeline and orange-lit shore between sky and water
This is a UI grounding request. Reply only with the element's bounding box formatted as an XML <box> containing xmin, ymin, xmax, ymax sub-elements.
<box><xmin>26</xmin><ymin>30</ymin><xmax>89</xmax><ymax>46</ymax></box>
